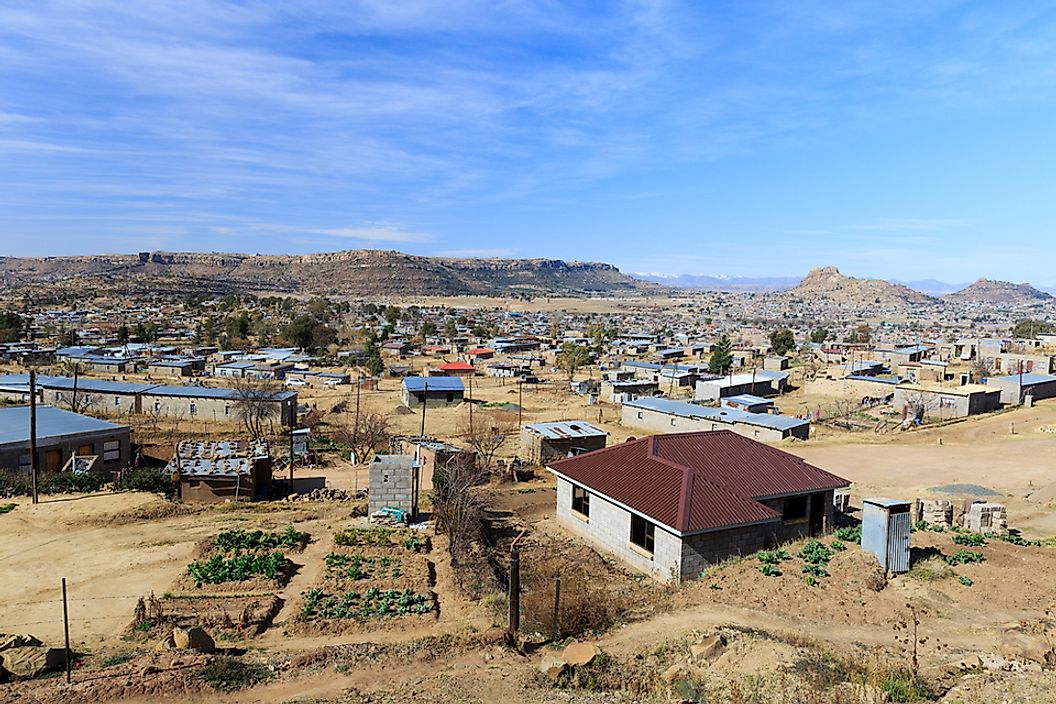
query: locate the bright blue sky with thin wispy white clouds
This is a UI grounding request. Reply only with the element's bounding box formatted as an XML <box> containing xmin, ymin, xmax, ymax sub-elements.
<box><xmin>0</xmin><ymin>0</ymin><xmax>1056</xmax><ymax>285</ymax></box>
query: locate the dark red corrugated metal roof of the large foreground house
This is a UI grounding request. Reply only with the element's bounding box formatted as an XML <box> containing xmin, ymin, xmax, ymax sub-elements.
<box><xmin>550</xmin><ymin>431</ymin><xmax>848</xmax><ymax>533</ymax></box>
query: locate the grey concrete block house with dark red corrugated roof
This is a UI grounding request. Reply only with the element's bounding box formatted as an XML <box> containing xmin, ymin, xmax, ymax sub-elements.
<box><xmin>547</xmin><ymin>431</ymin><xmax>849</xmax><ymax>582</ymax></box>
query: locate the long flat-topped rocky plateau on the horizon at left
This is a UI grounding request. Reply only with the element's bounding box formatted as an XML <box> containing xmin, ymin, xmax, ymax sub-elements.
<box><xmin>0</xmin><ymin>250</ymin><xmax>656</xmax><ymax>296</ymax></box>
